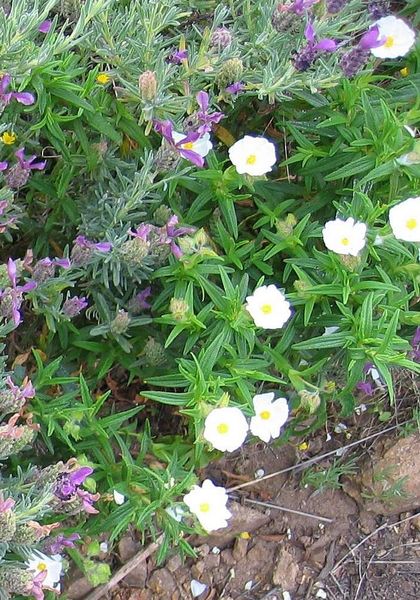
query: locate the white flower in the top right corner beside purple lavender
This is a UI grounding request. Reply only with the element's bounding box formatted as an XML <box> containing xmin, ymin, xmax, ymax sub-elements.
<box><xmin>371</xmin><ymin>15</ymin><xmax>416</xmax><ymax>58</ymax></box>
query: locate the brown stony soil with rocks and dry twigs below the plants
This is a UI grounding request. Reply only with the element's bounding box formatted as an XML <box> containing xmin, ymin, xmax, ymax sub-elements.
<box><xmin>68</xmin><ymin>430</ymin><xmax>420</xmax><ymax>600</ymax></box>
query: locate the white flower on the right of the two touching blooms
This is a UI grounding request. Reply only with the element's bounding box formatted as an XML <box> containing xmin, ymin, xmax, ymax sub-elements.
<box><xmin>250</xmin><ymin>392</ymin><xmax>289</xmax><ymax>442</ymax></box>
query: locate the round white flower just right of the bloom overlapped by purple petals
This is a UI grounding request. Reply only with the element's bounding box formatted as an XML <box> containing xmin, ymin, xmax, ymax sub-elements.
<box><xmin>229</xmin><ymin>135</ymin><xmax>276</xmax><ymax>177</ymax></box>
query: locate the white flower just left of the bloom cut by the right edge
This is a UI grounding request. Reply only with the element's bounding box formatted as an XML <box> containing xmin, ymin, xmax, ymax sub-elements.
<box><xmin>322</xmin><ymin>217</ymin><xmax>367</xmax><ymax>256</ymax></box>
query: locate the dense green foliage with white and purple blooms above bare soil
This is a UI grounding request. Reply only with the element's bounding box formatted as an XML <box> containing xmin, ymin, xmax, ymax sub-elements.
<box><xmin>0</xmin><ymin>0</ymin><xmax>420</xmax><ymax>599</ymax></box>
